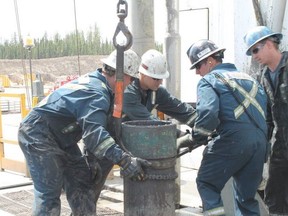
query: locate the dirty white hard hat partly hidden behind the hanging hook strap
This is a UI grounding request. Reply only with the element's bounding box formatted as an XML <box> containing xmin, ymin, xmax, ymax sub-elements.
<box><xmin>101</xmin><ymin>49</ymin><xmax>140</xmax><ymax>78</ymax></box>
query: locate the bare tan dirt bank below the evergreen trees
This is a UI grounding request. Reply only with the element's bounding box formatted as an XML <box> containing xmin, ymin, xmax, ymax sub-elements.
<box><xmin>0</xmin><ymin>55</ymin><xmax>106</xmax><ymax>85</ymax></box>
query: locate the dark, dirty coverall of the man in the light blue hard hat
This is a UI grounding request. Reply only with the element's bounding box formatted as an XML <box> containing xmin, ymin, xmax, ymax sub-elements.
<box><xmin>261</xmin><ymin>52</ymin><xmax>288</xmax><ymax>215</ymax></box>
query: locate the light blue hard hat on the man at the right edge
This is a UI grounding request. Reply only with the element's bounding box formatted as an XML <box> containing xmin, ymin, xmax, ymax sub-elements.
<box><xmin>244</xmin><ymin>26</ymin><xmax>283</xmax><ymax>56</ymax></box>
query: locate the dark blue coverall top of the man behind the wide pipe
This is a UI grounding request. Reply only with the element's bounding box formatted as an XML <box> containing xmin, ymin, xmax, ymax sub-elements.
<box><xmin>123</xmin><ymin>79</ymin><xmax>196</xmax><ymax>127</ymax></box>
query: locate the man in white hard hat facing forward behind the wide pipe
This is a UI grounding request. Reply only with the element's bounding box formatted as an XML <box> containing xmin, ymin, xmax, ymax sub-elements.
<box><xmin>123</xmin><ymin>49</ymin><xmax>196</xmax><ymax>132</ymax></box>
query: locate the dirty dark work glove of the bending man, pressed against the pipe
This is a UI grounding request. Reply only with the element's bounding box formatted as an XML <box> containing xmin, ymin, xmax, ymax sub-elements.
<box><xmin>117</xmin><ymin>152</ymin><xmax>151</xmax><ymax>181</ymax></box>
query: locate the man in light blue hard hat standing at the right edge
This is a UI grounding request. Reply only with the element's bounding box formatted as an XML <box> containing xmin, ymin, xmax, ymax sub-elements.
<box><xmin>244</xmin><ymin>26</ymin><xmax>288</xmax><ymax>215</ymax></box>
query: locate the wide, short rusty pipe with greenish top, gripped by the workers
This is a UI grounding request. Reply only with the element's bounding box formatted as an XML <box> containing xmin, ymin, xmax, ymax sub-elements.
<box><xmin>122</xmin><ymin>120</ymin><xmax>177</xmax><ymax>216</ymax></box>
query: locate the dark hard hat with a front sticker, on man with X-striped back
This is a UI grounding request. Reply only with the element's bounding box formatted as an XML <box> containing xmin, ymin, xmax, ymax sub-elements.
<box><xmin>187</xmin><ymin>39</ymin><xmax>226</xmax><ymax>69</ymax></box>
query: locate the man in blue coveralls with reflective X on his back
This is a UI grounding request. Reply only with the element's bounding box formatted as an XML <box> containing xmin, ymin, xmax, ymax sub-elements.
<box><xmin>183</xmin><ymin>39</ymin><xmax>267</xmax><ymax>216</ymax></box>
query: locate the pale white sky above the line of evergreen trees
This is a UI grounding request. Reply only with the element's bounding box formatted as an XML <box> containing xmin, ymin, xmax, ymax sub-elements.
<box><xmin>0</xmin><ymin>0</ymin><xmax>165</xmax><ymax>42</ymax></box>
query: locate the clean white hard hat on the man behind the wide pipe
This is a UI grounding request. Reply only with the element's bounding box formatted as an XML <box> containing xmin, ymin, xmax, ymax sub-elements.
<box><xmin>139</xmin><ymin>49</ymin><xmax>169</xmax><ymax>79</ymax></box>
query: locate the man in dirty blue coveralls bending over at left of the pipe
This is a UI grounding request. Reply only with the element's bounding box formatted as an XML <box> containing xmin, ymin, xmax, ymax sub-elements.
<box><xmin>18</xmin><ymin>50</ymin><xmax>150</xmax><ymax>216</ymax></box>
